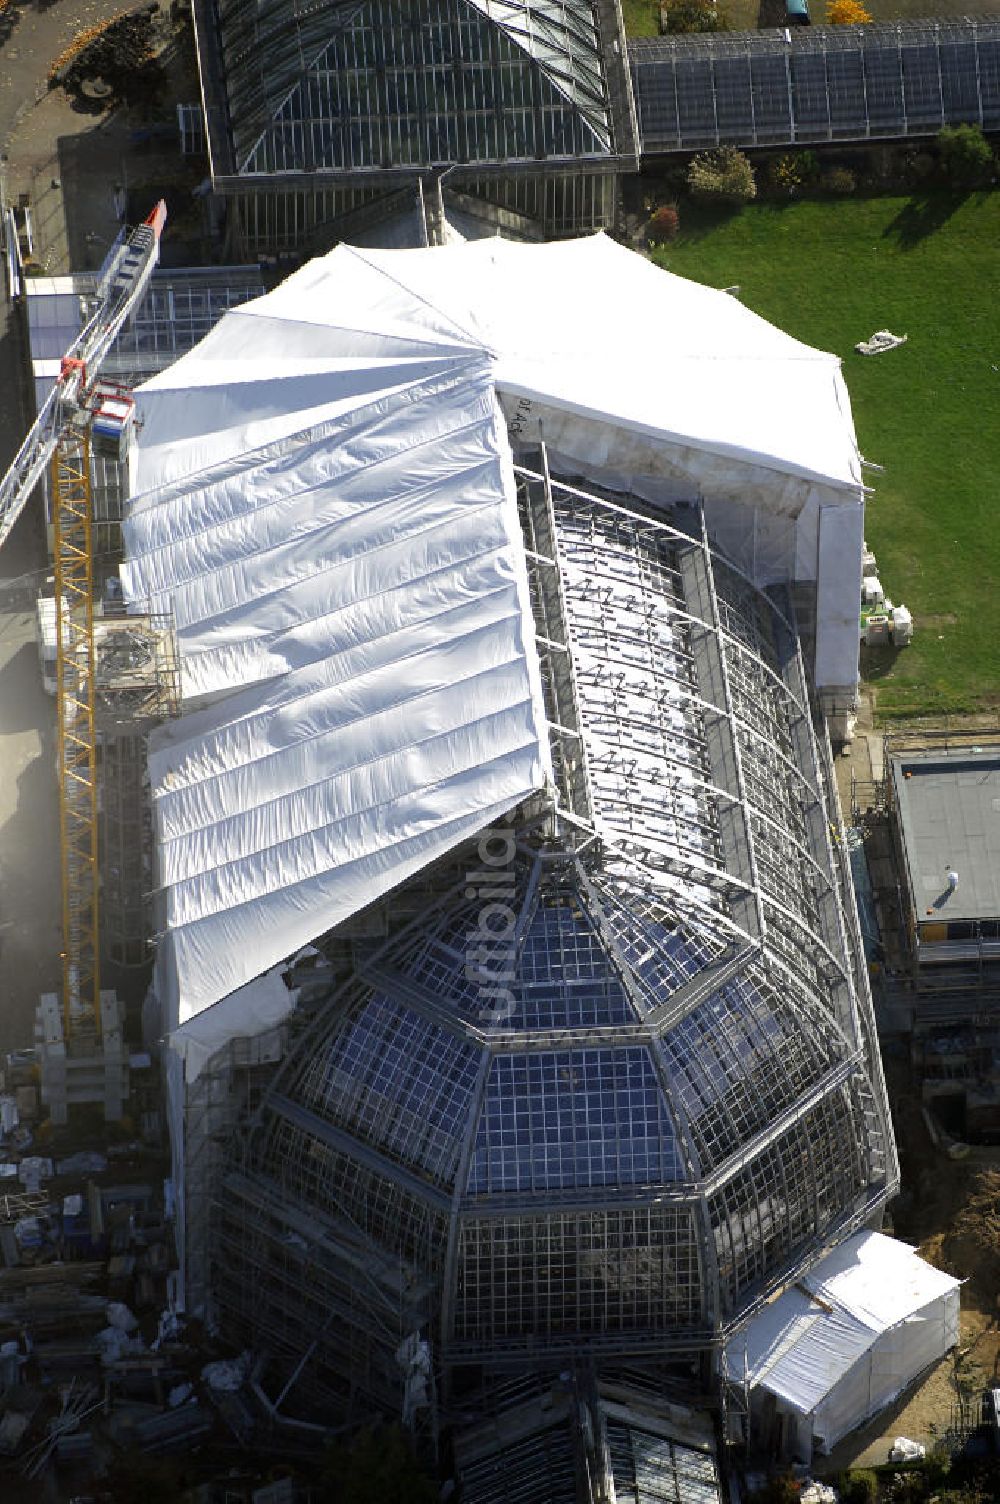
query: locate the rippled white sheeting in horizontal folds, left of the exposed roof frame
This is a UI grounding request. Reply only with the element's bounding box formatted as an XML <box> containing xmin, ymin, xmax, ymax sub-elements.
<box><xmin>123</xmin><ymin>358</ymin><xmax>549</xmax><ymax>1032</ymax></box>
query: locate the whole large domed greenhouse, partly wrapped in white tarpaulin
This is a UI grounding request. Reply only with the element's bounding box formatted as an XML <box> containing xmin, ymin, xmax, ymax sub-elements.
<box><xmin>122</xmin><ymin>236</ymin><xmax>898</xmax><ymax>1431</ymax></box>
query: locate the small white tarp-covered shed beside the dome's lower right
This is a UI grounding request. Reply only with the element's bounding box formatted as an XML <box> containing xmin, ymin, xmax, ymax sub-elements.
<box><xmin>726</xmin><ymin>1232</ymin><xmax>959</xmax><ymax>1451</ymax></box>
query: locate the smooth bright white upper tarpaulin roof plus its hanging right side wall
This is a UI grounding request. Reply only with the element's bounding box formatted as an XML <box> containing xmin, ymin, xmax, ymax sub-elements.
<box><xmin>129</xmin><ymin>235</ymin><xmax>863</xmax><ymax>705</ymax></box>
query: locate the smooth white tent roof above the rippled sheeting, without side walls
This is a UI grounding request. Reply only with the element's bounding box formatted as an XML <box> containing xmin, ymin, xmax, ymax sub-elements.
<box><xmin>134</xmin><ymin>235</ymin><xmax>860</xmax><ymax>496</ymax></box>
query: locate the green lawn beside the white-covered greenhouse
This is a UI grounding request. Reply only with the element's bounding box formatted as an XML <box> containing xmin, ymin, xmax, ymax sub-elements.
<box><xmin>656</xmin><ymin>193</ymin><xmax>1000</xmax><ymax>717</ymax></box>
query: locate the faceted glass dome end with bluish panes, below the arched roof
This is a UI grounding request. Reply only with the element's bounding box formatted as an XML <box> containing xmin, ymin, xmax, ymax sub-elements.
<box><xmin>240</xmin><ymin>844</ymin><xmax>886</xmax><ymax>1361</ymax></box>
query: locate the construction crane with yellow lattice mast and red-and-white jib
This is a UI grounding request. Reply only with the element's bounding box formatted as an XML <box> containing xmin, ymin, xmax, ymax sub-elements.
<box><xmin>0</xmin><ymin>200</ymin><xmax>167</xmax><ymax>1119</ymax></box>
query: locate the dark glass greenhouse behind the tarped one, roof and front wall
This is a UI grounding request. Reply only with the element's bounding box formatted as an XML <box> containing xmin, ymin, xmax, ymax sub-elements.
<box><xmin>194</xmin><ymin>0</ymin><xmax>638</xmax><ymax>257</ymax></box>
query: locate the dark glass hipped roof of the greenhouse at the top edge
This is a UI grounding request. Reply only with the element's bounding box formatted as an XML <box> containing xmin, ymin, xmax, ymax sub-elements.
<box><xmin>200</xmin><ymin>0</ymin><xmax>612</xmax><ymax>177</ymax></box>
